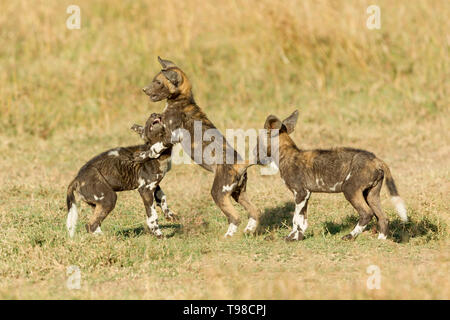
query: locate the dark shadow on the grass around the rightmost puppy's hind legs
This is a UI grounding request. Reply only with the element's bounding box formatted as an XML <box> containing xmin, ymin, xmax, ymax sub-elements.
<box><xmin>323</xmin><ymin>215</ymin><xmax>442</xmax><ymax>243</ymax></box>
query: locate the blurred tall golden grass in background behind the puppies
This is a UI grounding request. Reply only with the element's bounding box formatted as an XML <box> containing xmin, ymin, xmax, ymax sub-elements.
<box><xmin>0</xmin><ymin>0</ymin><xmax>450</xmax><ymax>139</ymax></box>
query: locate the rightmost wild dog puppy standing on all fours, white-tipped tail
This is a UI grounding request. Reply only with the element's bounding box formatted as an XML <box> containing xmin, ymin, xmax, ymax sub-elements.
<box><xmin>258</xmin><ymin>111</ymin><xmax>408</xmax><ymax>241</ymax></box>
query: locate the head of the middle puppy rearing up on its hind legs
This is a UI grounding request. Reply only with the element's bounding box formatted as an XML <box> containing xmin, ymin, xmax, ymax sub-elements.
<box><xmin>142</xmin><ymin>57</ymin><xmax>192</xmax><ymax>102</ymax></box>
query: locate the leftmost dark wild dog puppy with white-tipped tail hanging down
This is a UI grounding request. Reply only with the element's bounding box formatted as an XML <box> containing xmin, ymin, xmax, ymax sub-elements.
<box><xmin>67</xmin><ymin>113</ymin><xmax>176</xmax><ymax>237</ymax></box>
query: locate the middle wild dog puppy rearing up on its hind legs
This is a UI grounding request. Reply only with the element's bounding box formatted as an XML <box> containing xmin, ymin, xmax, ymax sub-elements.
<box><xmin>137</xmin><ymin>57</ymin><xmax>260</xmax><ymax>237</ymax></box>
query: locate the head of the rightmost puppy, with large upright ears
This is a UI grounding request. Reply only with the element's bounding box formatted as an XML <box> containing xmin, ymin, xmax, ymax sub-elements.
<box><xmin>253</xmin><ymin>110</ymin><xmax>298</xmax><ymax>165</ymax></box>
